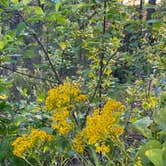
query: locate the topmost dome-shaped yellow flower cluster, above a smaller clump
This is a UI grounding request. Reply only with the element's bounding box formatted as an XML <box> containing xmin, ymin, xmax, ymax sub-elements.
<box><xmin>46</xmin><ymin>81</ymin><xmax>86</xmax><ymax>111</ymax></box>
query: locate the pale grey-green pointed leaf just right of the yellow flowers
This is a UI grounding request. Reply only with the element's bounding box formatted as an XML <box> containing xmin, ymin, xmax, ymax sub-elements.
<box><xmin>133</xmin><ymin>117</ymin><xmax>153</xmax><ymax>138</ymax></box>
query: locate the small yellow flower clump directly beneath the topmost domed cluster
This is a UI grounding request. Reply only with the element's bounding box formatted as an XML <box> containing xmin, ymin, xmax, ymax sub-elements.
<box><xmin>52</xmin><ymin>110</ymin><xmax>73</xmax><ymax>135</ymax></box>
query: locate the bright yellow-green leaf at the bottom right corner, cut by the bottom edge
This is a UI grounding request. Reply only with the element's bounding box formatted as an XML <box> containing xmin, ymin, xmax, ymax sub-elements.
<box><xmin>145</xmin><ymin>149</ymin><xmax>164</xmax><ymax>166</ymax></box>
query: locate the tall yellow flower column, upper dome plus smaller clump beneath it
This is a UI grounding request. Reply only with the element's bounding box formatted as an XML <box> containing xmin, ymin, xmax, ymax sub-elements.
<box><xmin>46</xmin><ymin>81</ymin><xmax>86</xmax><ymax>134</ymax></box>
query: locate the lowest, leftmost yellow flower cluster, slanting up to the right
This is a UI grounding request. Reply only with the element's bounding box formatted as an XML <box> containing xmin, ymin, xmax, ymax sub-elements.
<box><xmin>12</xmin><ymin>129</ymin><xmax>53</xmax><ymax>157</ymax></box>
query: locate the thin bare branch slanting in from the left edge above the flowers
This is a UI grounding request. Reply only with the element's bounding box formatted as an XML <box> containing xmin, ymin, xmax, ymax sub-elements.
<box><xmin>0</xmin><ymin>65</ymin><xmax>55</xmax><ymax>83</ymax></box>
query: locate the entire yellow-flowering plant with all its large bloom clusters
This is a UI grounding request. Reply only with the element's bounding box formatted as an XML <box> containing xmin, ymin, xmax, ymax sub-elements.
<box><xmin>12</xmin><ymin>81</ymin><xmax>124</xmax><ymax>163</ymax></box>
